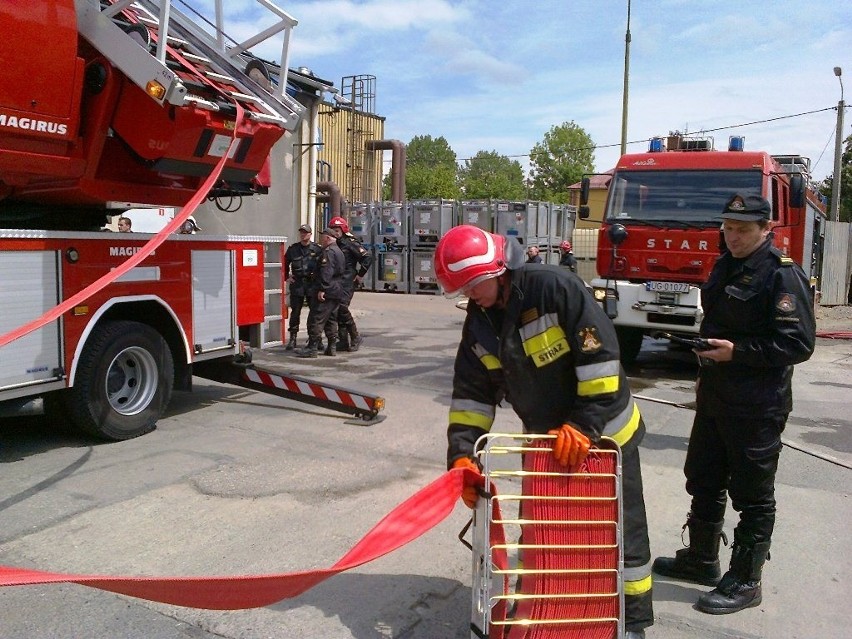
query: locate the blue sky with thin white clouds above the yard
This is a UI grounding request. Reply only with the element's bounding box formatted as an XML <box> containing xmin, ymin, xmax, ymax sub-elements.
<box><xmin>218</xmin><ymin>0</ymin><xmax>852</xmax><ymax>180</ymax></box>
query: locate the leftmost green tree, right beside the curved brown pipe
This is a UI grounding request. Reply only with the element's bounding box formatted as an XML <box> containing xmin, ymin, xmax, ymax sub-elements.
<box><xmin>382</xmin><ymin>135</ymin><xmax>459</xmax><ymax>200</ymax></box>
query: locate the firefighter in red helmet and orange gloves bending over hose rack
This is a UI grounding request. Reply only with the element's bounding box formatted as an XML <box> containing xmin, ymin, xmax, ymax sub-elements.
<box><xmin>435</xmin><ymin>225</ymin><xmax>654</xmax><ymax>639</ymax></box>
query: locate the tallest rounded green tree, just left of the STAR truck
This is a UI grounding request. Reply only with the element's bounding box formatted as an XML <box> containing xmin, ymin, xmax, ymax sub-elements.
<box><xmin>530</xmin><ymin>120</ymin><xmax>595</xmax><ymax>203</ymax></box>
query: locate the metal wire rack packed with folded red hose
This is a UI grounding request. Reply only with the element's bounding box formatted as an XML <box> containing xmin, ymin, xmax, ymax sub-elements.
<box><xmin>459</xmin><ymin>433</ymin><xmax>624</xmax><ymax>639</ymax></box>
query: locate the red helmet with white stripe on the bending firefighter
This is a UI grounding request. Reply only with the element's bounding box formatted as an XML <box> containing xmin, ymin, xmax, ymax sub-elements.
<box><xmin>435</xmin><ymin>224</ymin><xmax>524</xmax><ymax>296</ymax></box>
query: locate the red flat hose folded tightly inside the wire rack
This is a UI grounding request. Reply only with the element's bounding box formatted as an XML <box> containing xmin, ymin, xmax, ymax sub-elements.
<box><xmin>490</xmin><ymin>441</ymin><xmax>620</xmax><ymax>639</ymax></box>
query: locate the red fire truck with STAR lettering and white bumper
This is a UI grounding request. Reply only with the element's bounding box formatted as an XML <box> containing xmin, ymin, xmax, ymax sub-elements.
<box><xmin>579</xmin><ymin>133</ymin><xmax>825</xmax><ymax>363</ymax></box>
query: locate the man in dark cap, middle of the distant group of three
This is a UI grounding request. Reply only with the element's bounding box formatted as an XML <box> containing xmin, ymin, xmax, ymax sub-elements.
<box><xmin>298</xmin><ymin>227</ymin><xmax>346</xmax><ymax>357</ymax></box>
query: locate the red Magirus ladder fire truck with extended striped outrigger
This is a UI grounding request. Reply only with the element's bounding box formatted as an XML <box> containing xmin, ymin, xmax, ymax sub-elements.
<box><xmin>0</xmin><ymin>0</ymin><xmax>383</xmax><ymax>440</ymax></box>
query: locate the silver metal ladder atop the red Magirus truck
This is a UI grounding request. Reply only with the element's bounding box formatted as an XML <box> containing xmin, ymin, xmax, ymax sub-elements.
<box><xmin>75</xmin><ymin>0</ymin><xmax>304</xmax><ymax>131</ymax></box>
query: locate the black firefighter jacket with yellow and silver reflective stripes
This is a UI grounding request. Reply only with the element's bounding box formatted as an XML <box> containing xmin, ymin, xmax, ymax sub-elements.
<box><xmin>447</xmin><ymin>264</ymin><xmax>644</xmax><ymax>466</ymax></box>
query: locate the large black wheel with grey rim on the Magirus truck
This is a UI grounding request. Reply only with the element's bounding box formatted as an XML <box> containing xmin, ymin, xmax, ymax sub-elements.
<box><xmin>65</xmin><ymin>321</ymin><xmax>174</xmax><ymax>441</ymax></box>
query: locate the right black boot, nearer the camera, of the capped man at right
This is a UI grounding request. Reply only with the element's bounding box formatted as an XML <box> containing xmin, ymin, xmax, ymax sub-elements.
<box><xmin>695</xmin><ymin>534</ymin><xmax>769</xmax><ymax>615</ymax></box>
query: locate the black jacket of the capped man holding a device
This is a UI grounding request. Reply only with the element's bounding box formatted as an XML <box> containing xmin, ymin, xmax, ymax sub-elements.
<box><xmin>697</xmin><ymin>240</ymin><xmax>816</xmax><ymax>417</ymax></box>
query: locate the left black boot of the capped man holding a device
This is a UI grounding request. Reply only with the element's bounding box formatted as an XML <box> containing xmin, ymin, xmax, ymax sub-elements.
<box><xmin>653</xmin><ymin>513</ymin><xmax>728</xmax><ymax>586</ymax></box>
